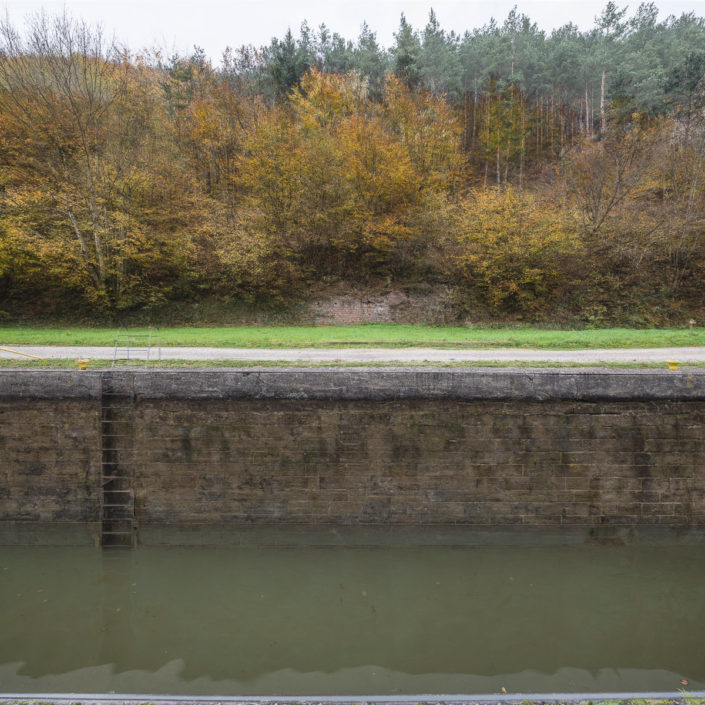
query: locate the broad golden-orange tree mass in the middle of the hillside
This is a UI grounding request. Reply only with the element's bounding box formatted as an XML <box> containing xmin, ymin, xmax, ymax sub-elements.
<box><xmin>226</xmin><ymin>70</ymin><xmax>462</xmax><ymax>292</ymax></box>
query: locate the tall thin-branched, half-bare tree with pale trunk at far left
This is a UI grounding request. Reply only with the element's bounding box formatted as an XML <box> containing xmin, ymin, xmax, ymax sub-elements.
<box><xmin>0</xmin><ymin>16</ymin><xmax>134</xmax><ymax>302</ymax></box>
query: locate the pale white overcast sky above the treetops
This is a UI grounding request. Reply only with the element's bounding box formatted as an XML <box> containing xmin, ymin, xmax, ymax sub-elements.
<box><xmin>0</xmin><ymin>0</ymin><xmax>705</xmax><ymax>60</ymax></box>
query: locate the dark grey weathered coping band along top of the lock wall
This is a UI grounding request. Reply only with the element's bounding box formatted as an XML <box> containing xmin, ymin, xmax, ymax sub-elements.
<box><xmin>0</xmin><ymin>367</ymin><xmax>705</xmax><ymax>401</ymax></box>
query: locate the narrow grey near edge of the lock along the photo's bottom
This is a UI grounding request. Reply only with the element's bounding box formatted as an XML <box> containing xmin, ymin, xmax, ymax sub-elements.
<box><xmin>0</xmin><ymin>690</ymin><xmax>705</xmax><ymax>705</ymax></box>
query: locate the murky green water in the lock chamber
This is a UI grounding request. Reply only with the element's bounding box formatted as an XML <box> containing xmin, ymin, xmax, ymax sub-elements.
<box><xmin>0</xmin><ymin>545</ymin><xmax>705</xmax><ymax>695</ymax></box>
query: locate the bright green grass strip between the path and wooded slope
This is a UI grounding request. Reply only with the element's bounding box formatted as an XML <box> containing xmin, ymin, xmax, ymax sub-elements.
<box><xmin>0</xmin><ymin>324</ymin><xmax>705</xmax><ymax>350</ymax></box>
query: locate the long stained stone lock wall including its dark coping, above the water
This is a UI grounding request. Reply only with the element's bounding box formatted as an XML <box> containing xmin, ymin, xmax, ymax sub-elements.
<box><xmin>0</xmin><ymin>368</ymin><xmax>705</xmax><ymax>542</ymax></box>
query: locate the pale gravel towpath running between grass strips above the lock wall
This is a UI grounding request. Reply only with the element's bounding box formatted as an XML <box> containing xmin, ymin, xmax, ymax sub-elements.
<box><xmin>0</xmin><ymin>342</ymin><xmax>705</xmax><ymax>364</ymax></box>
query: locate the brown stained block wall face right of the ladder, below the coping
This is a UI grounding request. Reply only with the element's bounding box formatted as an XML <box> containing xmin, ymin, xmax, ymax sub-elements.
<box><xmin>135</xmin><ymin>400</ymin><xmax>705</xmax><ymax>527</ymax></box>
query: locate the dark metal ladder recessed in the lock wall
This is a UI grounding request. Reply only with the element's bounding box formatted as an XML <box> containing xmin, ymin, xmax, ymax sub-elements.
<box><xmin>100</xmin><ymin>373</ymin><xmax>135</xmax><ymax>548</ymax></box>
